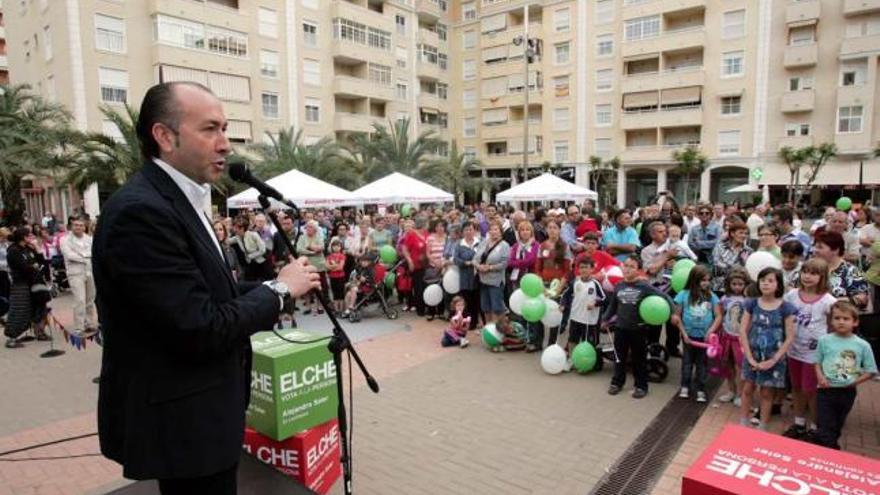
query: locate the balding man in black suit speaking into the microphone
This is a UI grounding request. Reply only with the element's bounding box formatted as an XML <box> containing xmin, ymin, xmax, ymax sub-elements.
<box><xmin>93</xmin><ymin>83</ymin><xmax>320</xmax><ymax>495</ymax></box>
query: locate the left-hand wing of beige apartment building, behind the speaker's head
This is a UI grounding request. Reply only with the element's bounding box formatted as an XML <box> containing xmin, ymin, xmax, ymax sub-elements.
<box><xmin>6</xmin><ymin>0</ymin><xmax>450</xmax><ymax>212</ymax></box>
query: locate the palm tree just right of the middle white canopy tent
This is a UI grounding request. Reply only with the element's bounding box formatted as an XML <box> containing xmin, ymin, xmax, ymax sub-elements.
<box><xmin>418</xmin><ymin>140</ymin><xmax>492</xmax><ymax>204</ymax></box>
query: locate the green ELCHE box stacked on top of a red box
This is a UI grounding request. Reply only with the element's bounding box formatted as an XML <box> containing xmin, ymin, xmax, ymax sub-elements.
<box><xmin>247</xmin><ymin>329</ymin><xmax>339</xmax><ymax>441</ymax></box>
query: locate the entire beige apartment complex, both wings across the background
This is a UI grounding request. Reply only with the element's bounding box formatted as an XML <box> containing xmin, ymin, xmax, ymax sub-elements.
<box><xmin>6</xmin><ymin>0</ymin><xmax>880</xmax><ymax>210</ymax></box>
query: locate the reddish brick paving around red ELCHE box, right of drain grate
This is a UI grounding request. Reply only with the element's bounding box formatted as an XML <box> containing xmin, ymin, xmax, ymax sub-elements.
<box><xmin>652</xmin><ymin>381</ymin><xmax>880</xmax><ymax>495</ymax></box>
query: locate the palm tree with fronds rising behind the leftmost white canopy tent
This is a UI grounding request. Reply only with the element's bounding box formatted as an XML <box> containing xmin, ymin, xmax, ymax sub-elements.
<box><xmin>249</xmin><ymin>127</ymin><xmax>359</xmax><ymax>188</ymax></box>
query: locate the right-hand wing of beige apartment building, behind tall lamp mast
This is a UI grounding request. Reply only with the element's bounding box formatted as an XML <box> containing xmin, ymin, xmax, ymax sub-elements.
<box><xmin>452</xmin><ymin>0</ymin><xmax>880</xmax><ymax>204</ymax></box>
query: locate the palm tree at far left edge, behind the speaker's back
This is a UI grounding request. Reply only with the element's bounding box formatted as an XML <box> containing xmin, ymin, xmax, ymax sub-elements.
<box><xmin>0</xmin><ymin>84</ymin><xmax>76</xmax><ymax>225</ymax></box>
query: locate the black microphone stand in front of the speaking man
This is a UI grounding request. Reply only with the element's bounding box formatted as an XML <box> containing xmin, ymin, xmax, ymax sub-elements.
<box><xmin>257</xmin><ymin>194</ymin><xmax>379</xmax><ymax>495</ymax></box>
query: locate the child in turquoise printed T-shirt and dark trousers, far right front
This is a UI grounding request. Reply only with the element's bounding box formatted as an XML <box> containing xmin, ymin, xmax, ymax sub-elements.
<box><xmin>812</xmin><ymin>301</ymin><xmax>877</xmax><ymax>450</ymax></box>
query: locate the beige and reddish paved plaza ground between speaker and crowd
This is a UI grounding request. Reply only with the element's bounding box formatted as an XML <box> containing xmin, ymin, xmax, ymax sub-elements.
<box><xmin>0</xmin><ymin>296</ymin><xmax>880</xmax><ymax>495</ymax></box>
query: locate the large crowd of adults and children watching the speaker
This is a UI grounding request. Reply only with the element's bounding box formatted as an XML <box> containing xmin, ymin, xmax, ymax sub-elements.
<box><xmin>0</xmin><ymin>194</ymin><xmax>880</xmax><ymax>454</ymax></box>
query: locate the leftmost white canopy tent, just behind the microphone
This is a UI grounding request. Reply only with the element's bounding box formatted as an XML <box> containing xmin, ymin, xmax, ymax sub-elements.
<box><xmin>226</xmin><ymin>170</ymin><xmax>359</xmax><ymax>208</ymax></box>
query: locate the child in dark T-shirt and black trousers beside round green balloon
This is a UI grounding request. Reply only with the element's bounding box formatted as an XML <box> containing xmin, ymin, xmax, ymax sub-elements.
<box><xmin>602</xmin><ymin>254</ymin><xmax>672</xmax><ymax>399</ymax></box>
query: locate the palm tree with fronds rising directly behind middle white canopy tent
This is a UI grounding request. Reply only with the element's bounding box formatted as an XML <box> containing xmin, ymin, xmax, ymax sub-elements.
<box><xmin>362</xmin><ymin>119</ymin><xmax>443</xmax><ymax>181</ymax></box>
